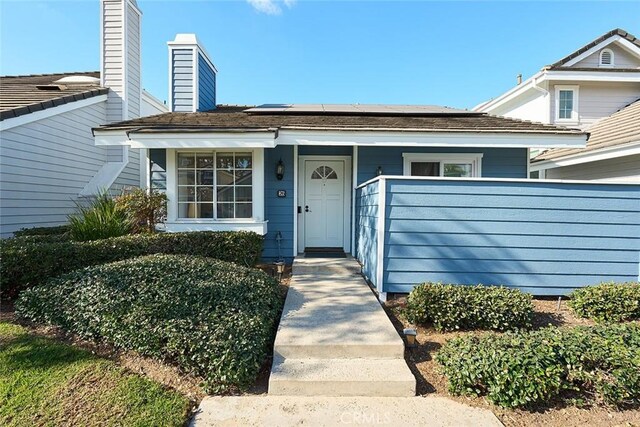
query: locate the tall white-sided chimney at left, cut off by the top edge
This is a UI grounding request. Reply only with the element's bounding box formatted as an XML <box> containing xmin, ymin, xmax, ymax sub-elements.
<box><xmin>100</xmin><ymin>0</ymin><xmax>142</xmax><ymax>122</ymax></box>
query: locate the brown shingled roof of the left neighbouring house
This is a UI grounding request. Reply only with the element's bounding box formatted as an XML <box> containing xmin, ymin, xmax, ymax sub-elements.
<box><xmin>0</xmin><ymin>71</ymin><xmax>108</xmax><ymax>120</ymax></box>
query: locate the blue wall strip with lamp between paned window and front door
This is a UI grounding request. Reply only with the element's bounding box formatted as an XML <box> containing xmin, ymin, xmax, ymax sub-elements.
<box><xmin>262</xmin><ymin>145</ymin><xmax>294</xmax><ymax>263</ymax></box>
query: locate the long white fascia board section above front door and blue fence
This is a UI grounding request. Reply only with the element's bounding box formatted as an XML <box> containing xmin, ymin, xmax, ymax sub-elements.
<box><xmin>276</xmin><ymin>130</ymin><xmax>587</xmax><ymax>148</ymax></box>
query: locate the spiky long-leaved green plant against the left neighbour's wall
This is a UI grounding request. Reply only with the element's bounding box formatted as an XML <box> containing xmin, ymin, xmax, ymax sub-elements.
<box><xmin>68</xmin><ymin>192</ymin><xmax>134</xmax><ymax>241</ymax></box>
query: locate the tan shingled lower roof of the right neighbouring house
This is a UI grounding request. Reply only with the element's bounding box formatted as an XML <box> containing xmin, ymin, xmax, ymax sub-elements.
<box><xmin>533</xmin><ymin>99</ymin><xmax>640</xmax><ymax>162</ymax></box>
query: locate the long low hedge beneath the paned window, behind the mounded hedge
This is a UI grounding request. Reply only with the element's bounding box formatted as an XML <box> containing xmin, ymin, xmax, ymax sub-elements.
<box><xmin>0</xmin><ymin>231</ymin><xmax>263</xmax><ymax>298</ymax></box>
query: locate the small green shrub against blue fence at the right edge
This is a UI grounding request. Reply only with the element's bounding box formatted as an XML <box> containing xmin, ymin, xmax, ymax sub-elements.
<box><xmin>568</xmin><ymin>282</ymin><xmax>640</xmax><ymax>322</ymax></box>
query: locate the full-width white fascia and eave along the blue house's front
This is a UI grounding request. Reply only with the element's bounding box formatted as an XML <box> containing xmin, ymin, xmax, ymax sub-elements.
<box><xmin>94</xmin><ymin>127</ymin><xmax>588</xmax><ymax>149</ymax></box>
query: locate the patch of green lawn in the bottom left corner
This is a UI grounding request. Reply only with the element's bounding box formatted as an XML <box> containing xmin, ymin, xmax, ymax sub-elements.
<box><xmin>0</xmin><ymin>322</ymin><xmax>191</xmax><ymax>426</ymax></box>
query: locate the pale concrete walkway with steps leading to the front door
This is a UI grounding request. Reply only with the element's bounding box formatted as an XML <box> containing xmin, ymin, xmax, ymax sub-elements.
<box><xmin>269</xmin><ymin>254</ymin><xmax>416</xmax><ymax>397</ymax></box>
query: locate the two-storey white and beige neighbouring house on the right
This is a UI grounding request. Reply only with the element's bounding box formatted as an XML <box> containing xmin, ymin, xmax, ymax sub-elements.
<box><xmin>474</xmin><ymin>28</ymin><xmax>640</xmax><ymax>181</ymax></box>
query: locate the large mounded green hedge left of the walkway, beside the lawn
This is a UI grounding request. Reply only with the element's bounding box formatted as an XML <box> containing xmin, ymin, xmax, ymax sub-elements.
<box><xmin>16</xmin><ymin>255</ymin><xmax>282</xmax><ymax>392</ymax></box>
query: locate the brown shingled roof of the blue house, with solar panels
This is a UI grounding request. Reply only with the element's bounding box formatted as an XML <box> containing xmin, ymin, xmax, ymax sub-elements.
<box><xmin>95</xmin><ymin>104</ymin><xmax>584</xmax><ymax>134</ymax></box>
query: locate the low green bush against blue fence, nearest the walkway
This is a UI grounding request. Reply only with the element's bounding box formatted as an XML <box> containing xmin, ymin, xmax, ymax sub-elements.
<box><xmin>405</xmin><ymin>283</ymin><xmax>533</xmax><ymax>331</ymax></box>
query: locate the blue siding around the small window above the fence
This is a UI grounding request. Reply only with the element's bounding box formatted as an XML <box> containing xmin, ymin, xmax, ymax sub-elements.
<box><xmin>358</xmin><ymin>147</ymin><xmax>529</xmax><ymax>184</ymax></box>
